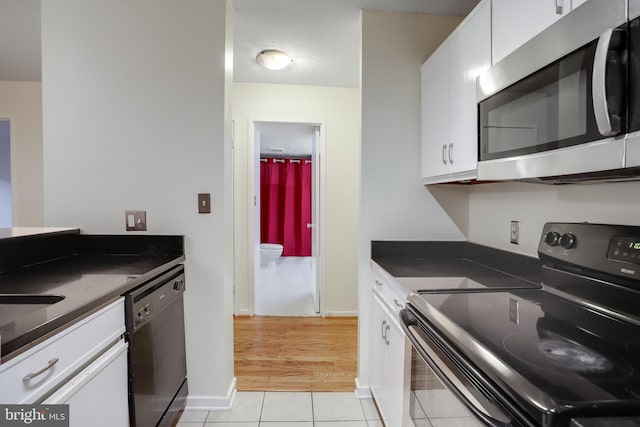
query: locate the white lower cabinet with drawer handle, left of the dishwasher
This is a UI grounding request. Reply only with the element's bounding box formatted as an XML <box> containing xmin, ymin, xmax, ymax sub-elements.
<box><xmin>0</xmin><ymin>298</ymin><xmax>129</xmax><ymax>427</ymax></box>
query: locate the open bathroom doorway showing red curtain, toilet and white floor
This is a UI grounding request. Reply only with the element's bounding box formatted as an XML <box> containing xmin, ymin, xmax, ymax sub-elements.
<box><xmin>250</xmin><ymin>121</ymin><xmax>321</xmax><ymax>316</ymax></box>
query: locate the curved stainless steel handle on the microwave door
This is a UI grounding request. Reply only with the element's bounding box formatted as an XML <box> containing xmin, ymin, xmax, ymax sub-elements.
<box><xmin>592</xmin><ymin>28</ymin><xmax>621</xmax><ymax>136</ymax></box>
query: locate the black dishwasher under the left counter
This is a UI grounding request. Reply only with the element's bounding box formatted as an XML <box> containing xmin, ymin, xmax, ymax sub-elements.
<box><xmin>125</xmin><ymin>265</ymin><xmax>188</xmax><ymax>427</ymax></box>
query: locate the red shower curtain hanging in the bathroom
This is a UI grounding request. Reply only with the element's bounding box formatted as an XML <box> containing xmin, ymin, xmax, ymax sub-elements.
<box><xmin>260</xmin><ymin>158</ymin><xmax>311</xmax><ymax>256</ymax></box>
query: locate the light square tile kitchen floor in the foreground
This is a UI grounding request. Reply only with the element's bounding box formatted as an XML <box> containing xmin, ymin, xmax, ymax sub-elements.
<box><xmin>177</xmin><ymin>391</ymin><xmax>383</xmax><ymax>427</ymax></box>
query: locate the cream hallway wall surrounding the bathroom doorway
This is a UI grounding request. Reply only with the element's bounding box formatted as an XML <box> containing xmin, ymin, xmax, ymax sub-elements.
<box><xmin>233</xmin><ymin>83</ymin><xmax>360</xmax><ymax>315</ymax></box>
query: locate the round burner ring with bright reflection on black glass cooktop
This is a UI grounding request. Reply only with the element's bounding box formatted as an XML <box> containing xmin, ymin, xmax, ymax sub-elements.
<box><xmin>538</xmin><ymin>339</ymin><xmax>615</xmax><ymax>374</ymax></box>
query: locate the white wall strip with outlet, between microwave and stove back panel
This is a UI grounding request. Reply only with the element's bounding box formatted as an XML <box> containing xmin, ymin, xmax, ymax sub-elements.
<box><xmin>469</xmin><ymin>182</ymin><xmax>640</xmax><ymax>257</ymax></box>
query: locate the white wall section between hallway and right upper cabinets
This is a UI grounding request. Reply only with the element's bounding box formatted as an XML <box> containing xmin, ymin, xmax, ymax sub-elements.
<box><xmin>358</xmin><ymin>11</ymin><xmax>465</xmax><ymax>394</ymax></box>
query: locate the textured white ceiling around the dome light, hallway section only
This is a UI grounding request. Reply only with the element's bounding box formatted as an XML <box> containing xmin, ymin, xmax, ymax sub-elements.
<box><xmin>231</xmin><ymin>0</ymin><xmax>478</xmax><ymax>87</ymax></box>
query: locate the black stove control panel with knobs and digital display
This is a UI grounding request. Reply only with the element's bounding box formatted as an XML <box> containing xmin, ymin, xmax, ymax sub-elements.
<box><xmin>538</xmin><ymin>222</ymin><xmax>640</xmax><ymax>280</ymax></box>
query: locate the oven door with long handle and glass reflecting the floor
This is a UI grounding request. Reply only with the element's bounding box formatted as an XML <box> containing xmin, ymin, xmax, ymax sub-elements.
<box><xmin>400</xmin><ymin>309</ymin><xmax>534</xmax><ymax>427</ymax></box>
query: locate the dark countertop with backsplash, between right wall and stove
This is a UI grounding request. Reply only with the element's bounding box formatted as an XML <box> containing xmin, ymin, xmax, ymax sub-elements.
<box><xmin>371</xmin><ymin>241</ymin><xmax>542</xmax><ymax>291</ymax></box>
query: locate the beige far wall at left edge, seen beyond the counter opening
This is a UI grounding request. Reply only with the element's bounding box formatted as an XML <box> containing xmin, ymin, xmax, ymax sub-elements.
<box><xmin>0</xmin><ymin>81</ymin><xmax>44</xmax><ymax>227</ymax></box>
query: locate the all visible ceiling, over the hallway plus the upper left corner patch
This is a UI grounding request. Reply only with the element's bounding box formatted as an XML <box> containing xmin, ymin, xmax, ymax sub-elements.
<box><xmin>0</xmin><ymin>0</ymin><xmax>478</xmax><ymax>87</ymax></box>
